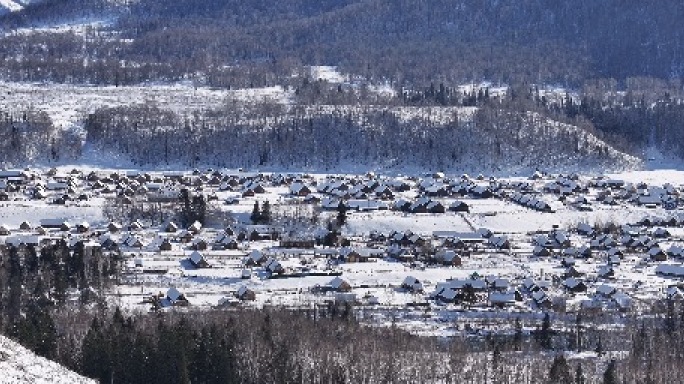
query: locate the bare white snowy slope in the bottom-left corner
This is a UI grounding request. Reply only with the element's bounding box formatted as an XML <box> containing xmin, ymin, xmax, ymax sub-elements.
<box><xmin>0</xmin><ymin>336</ymin><xmax>95</xmax><ymax>384</ymax></box>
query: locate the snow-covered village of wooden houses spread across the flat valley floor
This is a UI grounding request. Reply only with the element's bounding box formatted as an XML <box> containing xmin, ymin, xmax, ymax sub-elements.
<box><xmin>0</xmin><ymin>168</ymin><xmax>684</xmax><ymax>328</ymax></box>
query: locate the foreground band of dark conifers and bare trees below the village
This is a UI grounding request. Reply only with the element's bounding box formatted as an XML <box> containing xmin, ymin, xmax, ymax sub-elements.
<box><xmin>28</xmin><ymin>301</ymin><xmax>684</xmax><ymax>384</ymax></box>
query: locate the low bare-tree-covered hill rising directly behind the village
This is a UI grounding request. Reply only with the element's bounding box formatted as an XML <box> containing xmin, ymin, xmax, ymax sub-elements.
<box><xmin>85</xmin><ymin>96</ymin><xmax>637</xmax><ymax>172</ymax></box>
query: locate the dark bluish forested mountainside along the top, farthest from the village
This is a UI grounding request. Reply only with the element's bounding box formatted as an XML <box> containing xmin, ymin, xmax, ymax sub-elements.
<box><xmin>0</xmin><ymin>0</ymin><xmax>684</xmax><ymax>85</ymax></box>
